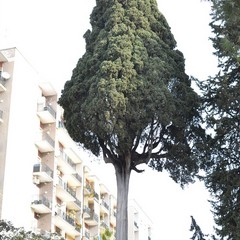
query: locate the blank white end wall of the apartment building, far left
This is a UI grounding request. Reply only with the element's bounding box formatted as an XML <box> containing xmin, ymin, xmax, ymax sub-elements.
<box><xmin>0</xmin><ymin>48</ymin><xmax>44</xmax><ymax>225</ymax></box>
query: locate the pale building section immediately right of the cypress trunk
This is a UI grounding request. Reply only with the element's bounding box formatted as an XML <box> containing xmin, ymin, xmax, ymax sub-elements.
<box><xmin>128</xmin><ymin>199</ymin><xmax>152</xmax><ymax>240</ymax></box>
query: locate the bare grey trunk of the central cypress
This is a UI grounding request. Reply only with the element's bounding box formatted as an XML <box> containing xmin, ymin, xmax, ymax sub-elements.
<box><xmin>115</xmin><ymin>156</ymin><xmax>131</xmax><ymax>240</ymax></box>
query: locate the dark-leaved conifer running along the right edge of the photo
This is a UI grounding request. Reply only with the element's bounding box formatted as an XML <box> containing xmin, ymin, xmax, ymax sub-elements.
<box><xmin>197</xmin><ymin>0</ymin><xmax>240</xmax><ymax>240</ymax></box>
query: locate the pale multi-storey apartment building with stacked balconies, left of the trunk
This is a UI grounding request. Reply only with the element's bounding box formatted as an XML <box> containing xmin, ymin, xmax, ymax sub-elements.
<box><xmin>0</xmin><ymin>48</ymin><xmax>150</xmax><ymax>240</ymax></box>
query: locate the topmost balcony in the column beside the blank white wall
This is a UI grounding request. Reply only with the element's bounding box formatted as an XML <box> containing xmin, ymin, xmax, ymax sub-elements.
<box><xmin>37</xmin><ymin>104</ymin><xmax>56</xmax><ymax>124</ymax></box>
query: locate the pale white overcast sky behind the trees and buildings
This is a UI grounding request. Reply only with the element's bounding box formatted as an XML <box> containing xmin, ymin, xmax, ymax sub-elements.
<box><xmin>0</xmin><ymin>0</ymin><xmax>217</xmax><ymax>240</ymax></box>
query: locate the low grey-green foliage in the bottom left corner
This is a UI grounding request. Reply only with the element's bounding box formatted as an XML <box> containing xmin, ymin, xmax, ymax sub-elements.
<box><xmin>0</xmin><ymin>220</ymin><xmax>64</xmax><ymax>240</ymax></box>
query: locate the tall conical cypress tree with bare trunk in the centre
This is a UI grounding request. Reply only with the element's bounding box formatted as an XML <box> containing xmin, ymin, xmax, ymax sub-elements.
<box><xmin>59</xmin><ymin>0</ymin><xmax>201</xmax><ymax>240</ymax></box>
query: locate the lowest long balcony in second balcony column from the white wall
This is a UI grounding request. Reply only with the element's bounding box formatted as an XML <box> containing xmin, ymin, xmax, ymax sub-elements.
<box><xmin>54</xmin><ymin>209</ymin><xmax>81</xmax><ymax>238</ymax></box>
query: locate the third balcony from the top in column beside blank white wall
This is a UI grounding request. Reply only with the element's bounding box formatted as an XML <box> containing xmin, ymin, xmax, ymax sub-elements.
<box><xmin>33</xmin><ymin>163</ymin><xmax>53</xmax><ymax>184</ymax></box>
